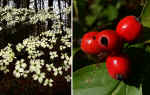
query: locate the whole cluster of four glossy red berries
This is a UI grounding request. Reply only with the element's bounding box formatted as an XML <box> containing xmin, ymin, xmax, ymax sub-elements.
<box><xmin>81</xmin><ymin>16</ymin><xmax>142</xmax><ymax>80</ymax></box>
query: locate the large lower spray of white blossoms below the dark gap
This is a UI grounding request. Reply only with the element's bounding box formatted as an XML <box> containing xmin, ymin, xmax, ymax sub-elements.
<box><xmin>0</xmin><ymin>21</ymin><xmax>72</xmax><ymax>87</ymax></box>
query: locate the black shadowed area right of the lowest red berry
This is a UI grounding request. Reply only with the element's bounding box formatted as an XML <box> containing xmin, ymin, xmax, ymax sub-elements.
<box><xmin>124</xmin><ymin>48</ymin><xmax>150</xmax><ymax>95</ymax></box>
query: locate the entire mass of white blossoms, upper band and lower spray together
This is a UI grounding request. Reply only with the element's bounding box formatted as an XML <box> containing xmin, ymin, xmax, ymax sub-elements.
<box><xmin>0</xmin><ymin>7</ymin><xmax>72</xmax><ymax>87</ymax></box>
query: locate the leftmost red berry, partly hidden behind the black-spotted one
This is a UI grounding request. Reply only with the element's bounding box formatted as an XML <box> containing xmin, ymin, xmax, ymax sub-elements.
<box><xmin>81</xmin><ymin>32</ymin><xmax>100</xmax><ymax>54</ymax></box>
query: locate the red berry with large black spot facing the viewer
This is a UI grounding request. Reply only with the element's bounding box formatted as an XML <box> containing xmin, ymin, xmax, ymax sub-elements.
<box><xmin>96</xmin><ymin>30</ymin><xmax>122</xmax><ymax>51</ymax></box>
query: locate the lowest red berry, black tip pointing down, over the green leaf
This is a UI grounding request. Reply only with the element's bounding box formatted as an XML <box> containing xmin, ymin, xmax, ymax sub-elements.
<box><xmin>106</xmin><ymin>56</ymin><xmax>131</xmax><ymax>80</ymax></box>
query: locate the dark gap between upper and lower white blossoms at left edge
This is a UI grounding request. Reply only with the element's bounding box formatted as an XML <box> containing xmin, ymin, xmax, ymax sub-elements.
<box><xmin>0</xmin><ymin>24</ymin><xmax>44</xmax><ymax>48</ymax></box>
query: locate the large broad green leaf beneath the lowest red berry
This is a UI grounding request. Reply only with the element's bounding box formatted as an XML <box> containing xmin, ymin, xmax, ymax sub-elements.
<box><xmin>73</xmin><ymin>63</ymin><xmax>141</xmax><ymax>95</ymax></box>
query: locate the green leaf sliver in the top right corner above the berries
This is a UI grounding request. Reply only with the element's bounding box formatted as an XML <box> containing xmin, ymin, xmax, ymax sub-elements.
<box><xmin>142</xmin><ymin>0</ymin><xmax>150</xmax><ymax>28</ymax></box>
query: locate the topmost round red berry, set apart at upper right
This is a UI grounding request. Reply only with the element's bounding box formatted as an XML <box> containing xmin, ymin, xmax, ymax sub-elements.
<box><xmin>116</xmin><ymin>16</ymin><xmax>142</xmax><ymax>42</ymax></box>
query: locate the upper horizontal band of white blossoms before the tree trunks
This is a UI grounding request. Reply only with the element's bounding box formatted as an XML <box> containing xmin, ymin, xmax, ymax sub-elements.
<box><xmin>0</xmin><ymin>6</ymin><xmax>71</xmax><ymax>26</ymax></box>
